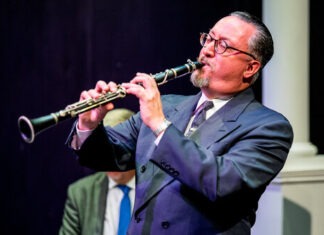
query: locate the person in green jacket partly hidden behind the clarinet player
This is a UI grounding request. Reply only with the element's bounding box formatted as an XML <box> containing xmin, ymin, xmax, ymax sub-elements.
<box><xmin>59</xmin><ymin>109</ymin><xmax>135</xmax><ymax>235</ymax></box>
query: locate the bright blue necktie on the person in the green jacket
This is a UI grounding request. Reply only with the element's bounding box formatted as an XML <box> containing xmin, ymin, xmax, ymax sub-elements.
<box><xmin>117</xmin><ymin>185</ymin><xmax>131</xmax><ymax>235</ymax></box>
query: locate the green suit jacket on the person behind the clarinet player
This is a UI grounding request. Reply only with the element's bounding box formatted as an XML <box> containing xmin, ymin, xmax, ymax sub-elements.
<box><xmin>59</xmin><ymin>172</ymin><xmax>108</xmax><ymax>235</ymax></box>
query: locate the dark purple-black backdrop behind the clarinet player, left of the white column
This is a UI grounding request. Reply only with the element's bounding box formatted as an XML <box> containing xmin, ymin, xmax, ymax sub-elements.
<box><xmin>8</xmin><ymin>0</ymin><xmax>324</xmax><ymax>235</ymax></box>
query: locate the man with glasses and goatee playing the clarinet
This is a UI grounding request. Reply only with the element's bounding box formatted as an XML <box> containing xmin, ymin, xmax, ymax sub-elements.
<box><xmin>67</xmin><ymin>11</ymin><xmax>293</xmax><ymax>235</ymax></box>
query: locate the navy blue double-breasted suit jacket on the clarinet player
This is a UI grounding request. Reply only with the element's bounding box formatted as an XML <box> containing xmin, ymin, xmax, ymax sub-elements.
<box><xmin>67</xmin><ymin>88</ymin><xmax>293</xmax><ymax>235</ymax></box>
